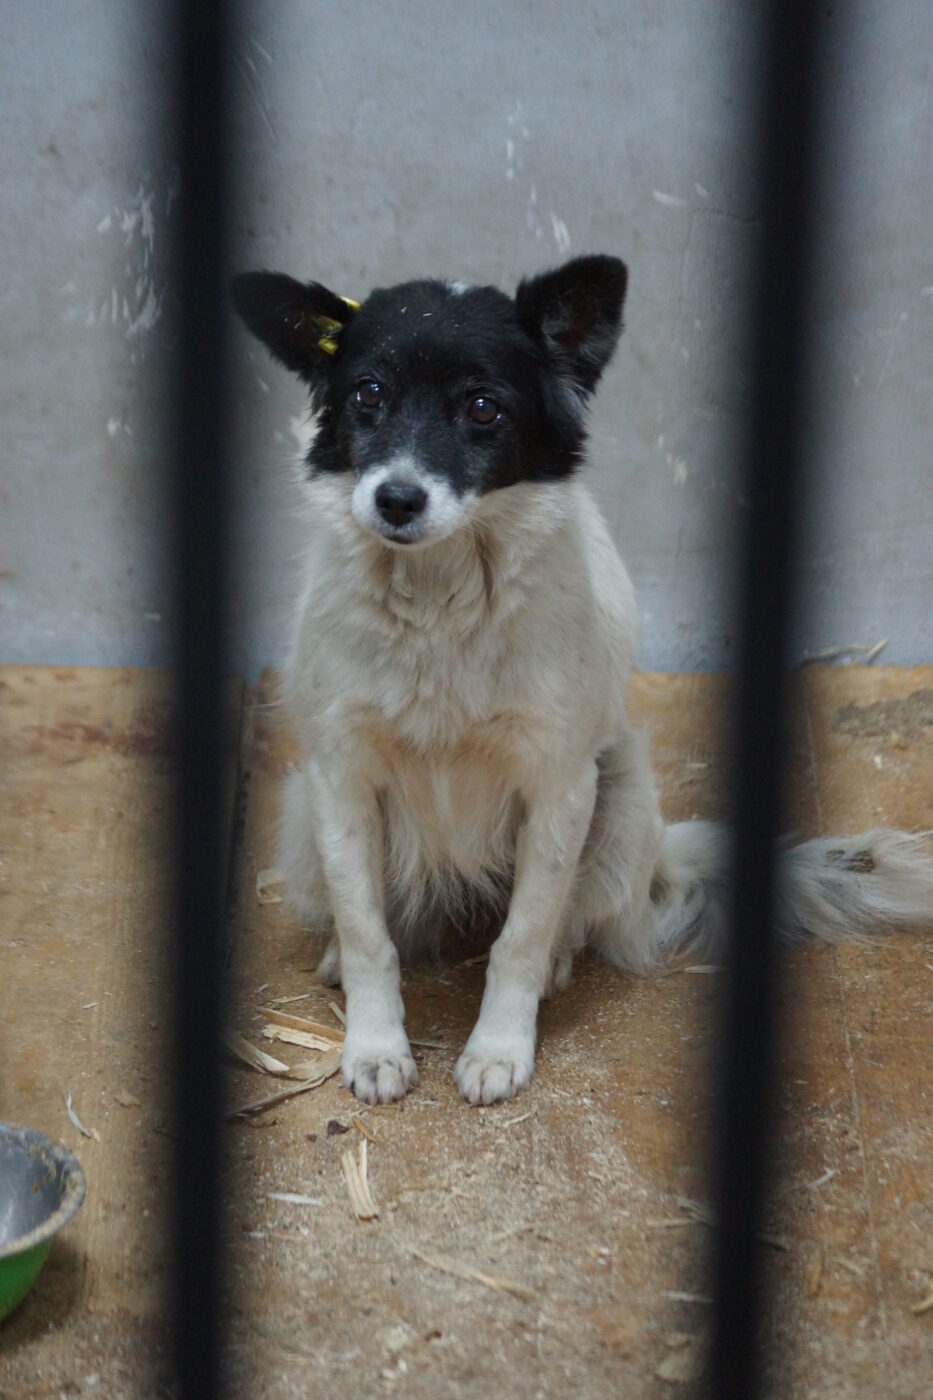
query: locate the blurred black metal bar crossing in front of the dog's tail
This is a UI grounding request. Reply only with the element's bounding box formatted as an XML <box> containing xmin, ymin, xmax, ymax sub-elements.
<box><xmin>707</xmin><ymin>10</ymin><xmax>818</xmax><ymax>1400</ymax></box>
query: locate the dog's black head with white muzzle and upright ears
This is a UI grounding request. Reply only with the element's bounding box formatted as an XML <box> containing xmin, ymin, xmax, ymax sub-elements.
<box><xmin>233</xmin><ymin>258</ymin><xmax>626</xmax><ymax>547</ymax></box>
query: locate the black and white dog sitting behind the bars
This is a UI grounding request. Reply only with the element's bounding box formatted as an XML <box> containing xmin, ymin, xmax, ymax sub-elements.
<box><xmin>233</xmin><ymin>256</ymin><xmax>933</xmax><ymax>1103</ymax></box>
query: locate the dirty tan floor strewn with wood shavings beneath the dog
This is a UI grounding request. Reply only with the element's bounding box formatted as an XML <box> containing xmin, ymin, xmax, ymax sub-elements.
<box><xmin>0</xmin><ymin>666</ymin><xmax>933</xmax><ymax>1400</ymax></box>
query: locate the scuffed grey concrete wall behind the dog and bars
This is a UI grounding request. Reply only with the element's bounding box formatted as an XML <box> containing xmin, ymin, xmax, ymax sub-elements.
<box><xmin>0</xmin><ymin>0</ymin><xmax>933</xmax><ymax>672</ymax></box>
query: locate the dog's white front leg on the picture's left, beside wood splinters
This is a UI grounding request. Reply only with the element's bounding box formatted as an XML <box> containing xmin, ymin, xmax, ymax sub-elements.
<box><xmin>308</xmin><ymin>763</ymin><xmax>417</xmax><ymax>1103</ymax></box>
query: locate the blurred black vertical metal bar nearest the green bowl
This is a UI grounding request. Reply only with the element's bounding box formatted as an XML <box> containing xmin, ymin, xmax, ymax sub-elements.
<box><xmin>170</xmin><ymin>0</ymin><xmax>231</xmax><ymax>1400</ymax></box>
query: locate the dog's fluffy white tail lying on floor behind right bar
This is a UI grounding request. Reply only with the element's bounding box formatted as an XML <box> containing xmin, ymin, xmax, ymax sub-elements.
<box><xmin>624</xmin><ymin>822</ymin><xmax>933</xmax><ymax>967</ymax></box>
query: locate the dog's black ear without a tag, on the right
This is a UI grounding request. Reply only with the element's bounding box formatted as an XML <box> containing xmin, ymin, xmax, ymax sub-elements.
<box><xmin>516</xmin><ymin>256</ymin><xmax>629</xmax><ymax>393</ymax></box>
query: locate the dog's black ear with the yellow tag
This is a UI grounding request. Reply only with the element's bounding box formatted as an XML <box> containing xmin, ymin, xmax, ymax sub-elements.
<box><xmin>230</xmin><ymin>272</ymin><xmax>360</xmax><ymax>384</ymax></box>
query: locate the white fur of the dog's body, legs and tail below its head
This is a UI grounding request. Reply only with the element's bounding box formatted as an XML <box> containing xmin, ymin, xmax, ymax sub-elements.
<box><xmin>282</xmin><ymin>476</ymin><xmax>933</xmax><ymax>1103</ymax></box>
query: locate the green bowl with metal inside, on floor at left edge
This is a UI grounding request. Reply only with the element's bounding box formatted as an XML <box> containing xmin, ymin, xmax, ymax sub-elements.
<box><xmin>0</xmin><ymin>1123</ymin><xmax>87</xmax><ymax>1322</ymax></box>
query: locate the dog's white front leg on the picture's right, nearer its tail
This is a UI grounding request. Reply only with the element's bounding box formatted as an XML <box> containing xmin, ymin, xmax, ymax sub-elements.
<box><xmin>454</xmin><ymin>763</ymin><xmax>597</xmax><ymax>1103</ymax></box>
